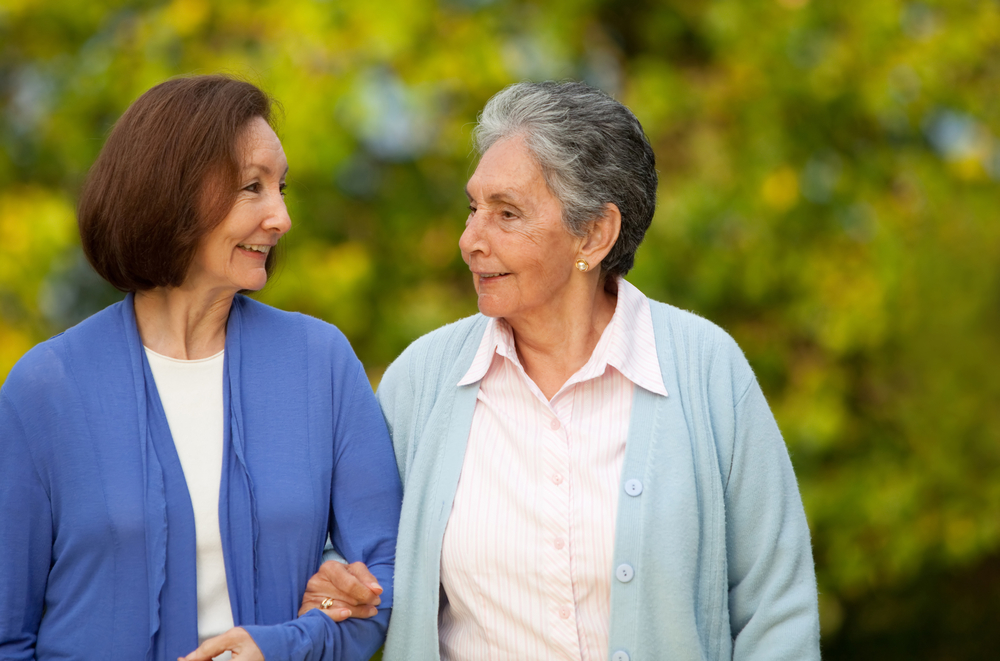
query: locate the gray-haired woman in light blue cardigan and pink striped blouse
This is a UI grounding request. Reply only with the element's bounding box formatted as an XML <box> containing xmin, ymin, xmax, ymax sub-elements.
<box><xmin>310</xmin><ymin>83</ymin><xmax>819</xmax><ymax>661</ymax></box>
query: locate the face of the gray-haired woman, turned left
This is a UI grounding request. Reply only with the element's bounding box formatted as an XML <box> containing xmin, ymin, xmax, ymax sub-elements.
<box><xmin>458</xmin><ymin>136</ymin><xmax>582</xmax><ymax>324</ymax></box>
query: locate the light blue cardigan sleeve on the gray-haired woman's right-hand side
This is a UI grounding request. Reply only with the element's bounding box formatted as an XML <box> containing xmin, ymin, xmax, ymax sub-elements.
<box><xmin>723</xmin><ymin>366</ymin><xmax>820</xmax><ymax>661</ymax></box>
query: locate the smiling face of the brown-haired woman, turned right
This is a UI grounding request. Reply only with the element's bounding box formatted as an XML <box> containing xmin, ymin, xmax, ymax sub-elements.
<box><xmin>184</xmin><ymin>117</ymin><xmax>292</xmax><ymax>293</ymax></box>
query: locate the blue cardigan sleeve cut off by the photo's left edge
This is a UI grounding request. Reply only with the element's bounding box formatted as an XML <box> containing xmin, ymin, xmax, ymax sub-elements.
<box><xmin>0</xmin><ymin>390</ymin><xmax>53</xmax><ymax>659</ymax></box>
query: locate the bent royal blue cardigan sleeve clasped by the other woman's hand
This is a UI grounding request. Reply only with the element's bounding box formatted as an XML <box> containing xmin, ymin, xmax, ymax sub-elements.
<box><xmin>244</xmin><ymin>360</ymin><xmax>403</xmax><ymax>661</ymax></box>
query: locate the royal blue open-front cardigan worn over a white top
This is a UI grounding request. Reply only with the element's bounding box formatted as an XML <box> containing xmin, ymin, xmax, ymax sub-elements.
<box><xmin>0</xmin><ymin>295</ymin><xmax>402</xmax><ymax>661</ymax></box>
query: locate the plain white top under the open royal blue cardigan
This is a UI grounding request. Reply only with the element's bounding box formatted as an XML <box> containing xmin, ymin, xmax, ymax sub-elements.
<box><xmin>146</xmin><ymin>347</ymin><xmax>233</xmax><ymax>658</ymax></box>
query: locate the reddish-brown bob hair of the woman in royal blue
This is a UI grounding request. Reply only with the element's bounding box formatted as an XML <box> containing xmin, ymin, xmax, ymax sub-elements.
<box><xmin>77</xmin><ymin>75</ymin><xmax>275</xmax><ymax>291</ymax></box>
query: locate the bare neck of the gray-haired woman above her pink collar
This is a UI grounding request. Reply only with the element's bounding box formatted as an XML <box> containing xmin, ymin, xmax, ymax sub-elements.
<box><xmin>507</xmin><ymin>276</ymin><xmax>617</xmax><ymax>399</ymax></box>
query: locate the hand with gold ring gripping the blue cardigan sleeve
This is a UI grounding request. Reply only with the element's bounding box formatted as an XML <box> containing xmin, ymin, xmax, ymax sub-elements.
<box><xmin>299</xmin><ymin>560</ymin><xmax>382</xmax><ymax>622</ymax></box>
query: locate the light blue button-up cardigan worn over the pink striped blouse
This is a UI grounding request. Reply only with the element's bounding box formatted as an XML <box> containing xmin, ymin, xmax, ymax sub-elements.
<box><xmin>377</xmin><ymin>301</ymin><xmax>819</xmax><ymax>661</ymax></box>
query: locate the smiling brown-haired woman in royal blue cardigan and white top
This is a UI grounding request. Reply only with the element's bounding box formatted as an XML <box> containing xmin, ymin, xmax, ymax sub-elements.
<box><xmin>0</xmin><ymin>76</ymin><xmax>401</xmax><ymax>661</ymax></box>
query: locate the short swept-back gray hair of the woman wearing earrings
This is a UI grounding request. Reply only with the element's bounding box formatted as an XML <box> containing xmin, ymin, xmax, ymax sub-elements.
<box><xmin>473</xmin><ymin>82</ymin><xmax>657</xmax><ymax>275</ymax></box>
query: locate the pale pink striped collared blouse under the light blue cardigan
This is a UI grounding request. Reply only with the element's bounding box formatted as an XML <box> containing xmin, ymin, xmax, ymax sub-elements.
<box><xmin>439</xmin><ymin>280</ymin><xmax>667</xmax><ymax>661</ymax></box>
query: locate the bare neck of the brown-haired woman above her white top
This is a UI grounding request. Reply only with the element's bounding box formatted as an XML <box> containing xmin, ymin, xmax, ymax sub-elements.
<box><xmin>135</xmin><ymin>286</ymin><xmax>235</xmax><ymax>360</ymax></box>
